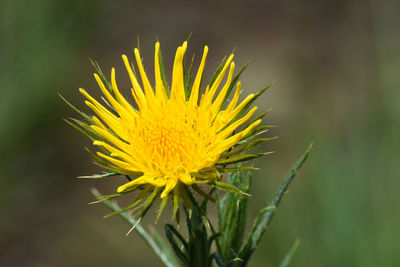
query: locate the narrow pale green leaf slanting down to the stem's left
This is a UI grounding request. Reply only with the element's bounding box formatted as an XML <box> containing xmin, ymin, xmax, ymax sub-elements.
<box><xmin>92</xmin><ymin>189</ymin><xmax>178</xmax><ymax>267</ymax></box>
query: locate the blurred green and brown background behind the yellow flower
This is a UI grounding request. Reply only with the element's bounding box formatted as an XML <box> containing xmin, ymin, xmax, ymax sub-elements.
<box><xmin>0</xmin><ymin>0</ymin><xmax>400</xmax><ymax>266</ymax></box>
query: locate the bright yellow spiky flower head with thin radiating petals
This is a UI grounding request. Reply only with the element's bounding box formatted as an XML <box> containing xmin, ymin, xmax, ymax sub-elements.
<box><xmin>66</xmin><ymin>42</ymin><xmax>272</xmax><ymax>221</ymax></box>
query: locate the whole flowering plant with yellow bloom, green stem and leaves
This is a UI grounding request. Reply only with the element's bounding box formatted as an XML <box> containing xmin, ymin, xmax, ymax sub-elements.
<box><xmin>64</xmin><ymin>39</ymin><xmax>310</xmax><ymax>266</ymax></box>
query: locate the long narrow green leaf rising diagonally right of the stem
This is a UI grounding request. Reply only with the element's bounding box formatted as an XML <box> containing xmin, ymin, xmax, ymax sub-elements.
<box><xmin>239</xmin><ymin>143</ymin><xmax>313</xmax><ymax>266</ymax></box>
